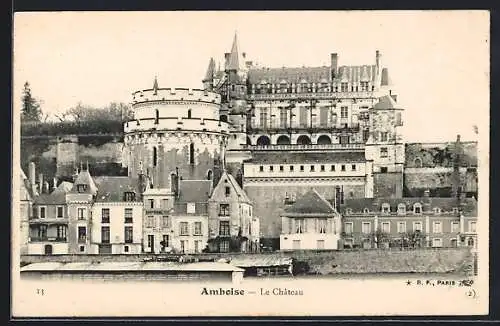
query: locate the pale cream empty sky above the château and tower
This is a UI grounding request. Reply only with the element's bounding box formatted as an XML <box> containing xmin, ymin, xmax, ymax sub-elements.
<box><xmin>13</xmin><ymin>11</ymin><xmax>489</xmax><ymax>142</ymax></box>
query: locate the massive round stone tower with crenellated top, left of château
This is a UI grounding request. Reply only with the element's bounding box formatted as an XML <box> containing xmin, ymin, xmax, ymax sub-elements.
<box><xmin>124</xmin><ymin>79</ymin><xmax>228</xmax><ymax>188</ymax></box>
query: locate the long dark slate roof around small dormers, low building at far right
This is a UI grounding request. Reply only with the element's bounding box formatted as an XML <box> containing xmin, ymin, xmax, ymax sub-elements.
<box><xmin>340</xmin><ymin>197</ymin><xmax>477</xmax><ymax>216</ymax></box>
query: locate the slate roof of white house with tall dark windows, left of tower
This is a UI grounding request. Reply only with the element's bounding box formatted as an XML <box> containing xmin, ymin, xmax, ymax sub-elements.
<box><xmin>95</xmin><ymin>177</ymin><xmax>140</xmax><ymax>202</ymax></box>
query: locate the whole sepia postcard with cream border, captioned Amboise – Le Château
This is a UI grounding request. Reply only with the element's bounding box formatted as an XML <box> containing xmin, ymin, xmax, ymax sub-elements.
<box><xmin>11</xmin><ymin>10</ymin><xmax>490</xmax><ymax>318</ymax></box>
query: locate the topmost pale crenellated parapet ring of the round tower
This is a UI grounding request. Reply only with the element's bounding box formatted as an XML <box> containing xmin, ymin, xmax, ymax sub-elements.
<box><xmin>132</xmin><ymin>88</ymin><xmax>221</xmax><ymax>105</ymax></box>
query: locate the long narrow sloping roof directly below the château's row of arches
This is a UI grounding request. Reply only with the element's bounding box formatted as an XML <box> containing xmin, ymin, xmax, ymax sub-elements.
<box><xmin>248</xmin><ymin>151</ymin><xmax>366</xmax><ymax>164</ymax></box>
